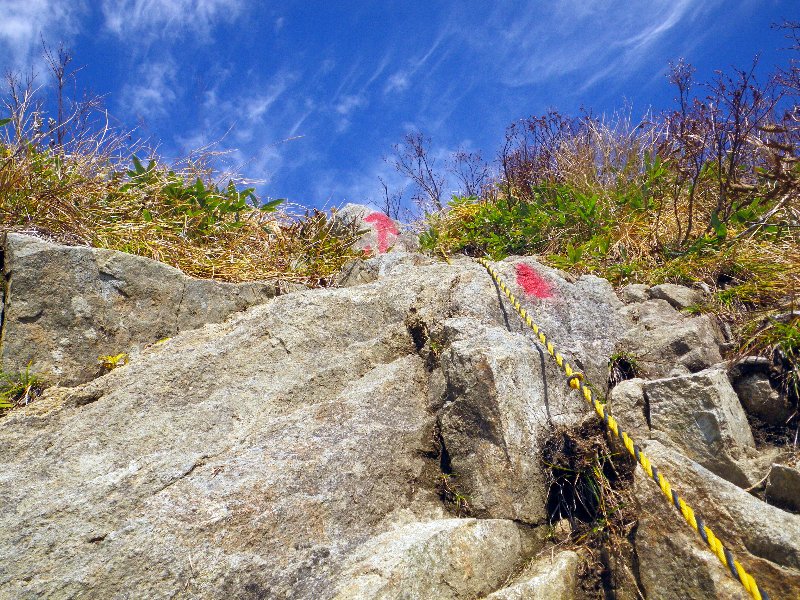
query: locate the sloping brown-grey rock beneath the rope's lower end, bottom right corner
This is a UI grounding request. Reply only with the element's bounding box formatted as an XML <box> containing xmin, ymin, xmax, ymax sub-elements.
<box><xmin>634</xmin><ymin>441</ymin><xmax>800</xmax><ymax>600</ymax></box>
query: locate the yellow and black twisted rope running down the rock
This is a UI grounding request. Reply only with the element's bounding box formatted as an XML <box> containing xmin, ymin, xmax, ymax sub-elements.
<box><xmin>476</xmin><ymin>258</ymin><xmax>769</xmax><ymax>600</ymax></box>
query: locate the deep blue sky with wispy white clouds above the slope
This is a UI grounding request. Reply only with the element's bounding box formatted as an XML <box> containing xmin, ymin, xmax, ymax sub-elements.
<box><xmin>0</xmin><ymin>0</ymin><xmax>800</xmax><ymax>211</ymax></box>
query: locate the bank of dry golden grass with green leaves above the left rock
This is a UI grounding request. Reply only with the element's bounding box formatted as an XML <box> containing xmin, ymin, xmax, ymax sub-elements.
<box><xmin>0</xmin><ymin>85</ymin><xmax>361</xmax><ymax>286</ymax></box>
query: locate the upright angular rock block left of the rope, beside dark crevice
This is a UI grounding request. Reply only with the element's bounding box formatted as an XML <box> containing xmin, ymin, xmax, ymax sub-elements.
<box><xmin>440</xmin><ymin>317</ymin><xmax>586</xmax><ymax>523</ymax></box>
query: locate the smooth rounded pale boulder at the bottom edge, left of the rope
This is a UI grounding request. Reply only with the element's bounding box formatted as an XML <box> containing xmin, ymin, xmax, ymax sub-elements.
<box><xmin>335</xmin><ymin>519</ymin><xmax>529</xmax><ymax>600</ymax></box>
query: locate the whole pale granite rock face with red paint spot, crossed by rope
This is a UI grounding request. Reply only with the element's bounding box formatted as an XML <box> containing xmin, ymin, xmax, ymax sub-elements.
<box><xmin>0</xmin><ymin>240</ymin><xmax>800</xmax><ymax>600</ymax></box>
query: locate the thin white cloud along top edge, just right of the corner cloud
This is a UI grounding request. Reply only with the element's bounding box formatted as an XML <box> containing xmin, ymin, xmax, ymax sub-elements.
<box><xmin>102</xmin><ymin>0</ymin><xmax>244</xmax><ymax>37</ymax></box>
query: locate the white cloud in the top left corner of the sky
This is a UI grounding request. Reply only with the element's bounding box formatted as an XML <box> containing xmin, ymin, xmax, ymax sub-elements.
<box><xmin>0</xmin><ymin>0</ymin><xmax>86</xmax><ymax>71</ymax></box>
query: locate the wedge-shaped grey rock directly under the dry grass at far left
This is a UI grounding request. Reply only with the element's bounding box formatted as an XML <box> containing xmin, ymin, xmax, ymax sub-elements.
<box><xmin>0</xmin><ymin>233</ymin><xmax>290</xmax><ymax>385</ymax></box>
